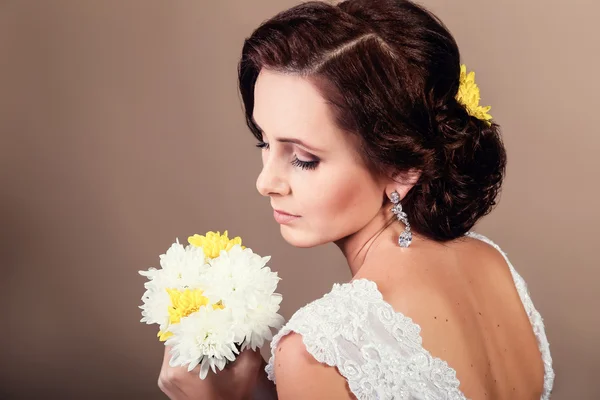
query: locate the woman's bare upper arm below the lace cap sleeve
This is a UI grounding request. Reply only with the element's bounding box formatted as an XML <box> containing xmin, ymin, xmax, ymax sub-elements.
<box><xmin>274</xmin><ymin>332</ymin><xmax>354</xmax><ymax>400</ymax></box>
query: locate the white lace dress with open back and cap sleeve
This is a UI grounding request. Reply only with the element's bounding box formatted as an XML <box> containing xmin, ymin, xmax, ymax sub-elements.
<box><xmin>265</xmin><ymin>232</ymin><xmax>554</xmax><ymax>400</ymax></box>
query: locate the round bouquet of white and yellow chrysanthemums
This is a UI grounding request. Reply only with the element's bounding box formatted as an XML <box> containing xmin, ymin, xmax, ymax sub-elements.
<box><xmin>139</xmin><ymin>231</ymin><xmax>283</xmax><ymax>379</ymax></box>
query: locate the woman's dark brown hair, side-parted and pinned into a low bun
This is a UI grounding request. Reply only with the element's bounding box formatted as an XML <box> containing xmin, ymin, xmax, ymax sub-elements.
<box><xmin>238</xmin><ymin>0</ymin><xmax>506</xmax><ymax>241</ymax></box>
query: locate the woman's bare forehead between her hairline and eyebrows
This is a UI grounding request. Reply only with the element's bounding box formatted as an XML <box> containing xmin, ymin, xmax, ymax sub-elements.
<box><xmin>253</xmin><ymin>68</ymin><xmax>335</xmax><ymax>140</ymax></box>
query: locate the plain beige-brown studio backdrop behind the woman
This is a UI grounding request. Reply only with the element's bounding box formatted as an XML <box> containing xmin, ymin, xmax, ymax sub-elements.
<box><xmin>0</xmin><ymin>0</ymin><xmax>600</xmax><ymax>400</ymax></box>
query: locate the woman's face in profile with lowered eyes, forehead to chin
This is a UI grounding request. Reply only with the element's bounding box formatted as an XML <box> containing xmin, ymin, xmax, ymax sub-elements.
<box><xmin>253</xmin><ymin>69</ymin><xmax>385</xmax><ymax>247</ymax></box>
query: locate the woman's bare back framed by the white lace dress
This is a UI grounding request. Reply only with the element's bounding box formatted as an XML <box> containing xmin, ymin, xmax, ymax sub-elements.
<box><xmin>355</xmin><ymin>233</ymin><xmax>544</xmax><ymax>400</ymax></box>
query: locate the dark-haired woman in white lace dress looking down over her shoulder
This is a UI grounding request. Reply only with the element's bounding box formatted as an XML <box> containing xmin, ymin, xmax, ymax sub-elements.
<box><xmin>159</xmin><ymin>0</ymin><xmax>554</xmax><ymax>400</ymax></box>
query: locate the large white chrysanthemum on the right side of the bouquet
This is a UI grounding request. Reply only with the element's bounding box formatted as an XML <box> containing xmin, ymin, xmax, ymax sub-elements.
<box><xmin>202</xmin><ymin>245</ymin><xmax>283</xmax><ymax>350</ymax></box>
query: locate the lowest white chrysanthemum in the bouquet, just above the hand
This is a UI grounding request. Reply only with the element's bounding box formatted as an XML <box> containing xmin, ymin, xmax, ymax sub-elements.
<box><xmin>165</xmin><ymin>307</ymin><xmax>239</xmax><ymax>379</ymax></box>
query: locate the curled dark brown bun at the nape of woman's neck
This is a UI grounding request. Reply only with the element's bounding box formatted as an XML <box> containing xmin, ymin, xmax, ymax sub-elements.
<box><xmin>407</xmin><ymin>99</ymin><xmax>506</xmax><ymax>240</ymax></box>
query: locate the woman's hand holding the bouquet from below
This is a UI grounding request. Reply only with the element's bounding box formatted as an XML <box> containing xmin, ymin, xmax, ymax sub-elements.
<box><xmin>158</xmin><ymin>346</ymin><xmax>265</xmax><ymax>400</ymax></box>
